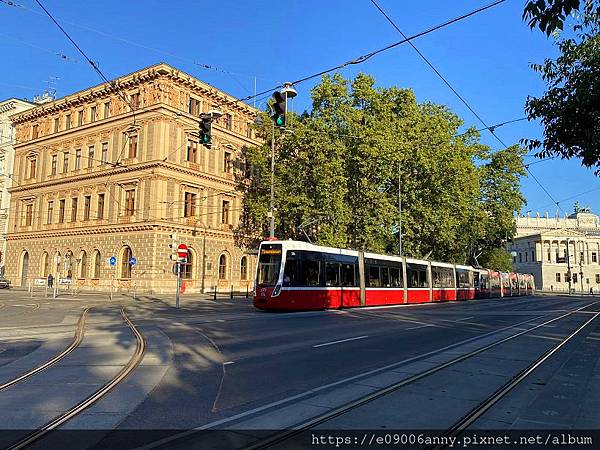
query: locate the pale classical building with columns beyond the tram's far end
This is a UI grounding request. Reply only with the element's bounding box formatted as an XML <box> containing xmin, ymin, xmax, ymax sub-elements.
<box><xmin>508</xmin><ymin>205</ymin><xmax>600</xmax><ymax>293</ymax></box>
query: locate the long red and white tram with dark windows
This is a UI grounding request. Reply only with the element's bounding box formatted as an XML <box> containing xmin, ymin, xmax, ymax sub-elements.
<box><xmin>254</xmin><ymin>240</ymin><xmax>533</xmax><ymax>310</ymax></box>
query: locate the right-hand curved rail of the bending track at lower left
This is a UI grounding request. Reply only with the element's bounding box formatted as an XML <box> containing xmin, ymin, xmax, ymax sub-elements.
<box><xmin>7</xmin><ymin>308</ymin><xmax>146</xmax><ymax>450</ymax></box>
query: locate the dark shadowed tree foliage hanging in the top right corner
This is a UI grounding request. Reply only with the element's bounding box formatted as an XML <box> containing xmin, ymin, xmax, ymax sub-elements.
<box><xmin>524</xmin><ymin>0</ymin><xmax>600</xmax><ymax>174</ymax></box>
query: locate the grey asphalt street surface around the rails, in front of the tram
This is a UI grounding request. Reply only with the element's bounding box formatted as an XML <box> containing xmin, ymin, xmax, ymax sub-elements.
<box><xmin>0</xmin><ymin>290</ymin><xmax>600</xmax><ymax>447</ymax></box>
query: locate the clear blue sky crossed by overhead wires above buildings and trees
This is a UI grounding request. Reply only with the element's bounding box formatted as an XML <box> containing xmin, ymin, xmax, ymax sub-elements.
<box><xmin>0</xmin><ymin>0</ymin><xmax>600</xmax><ymax>215</ymax></box>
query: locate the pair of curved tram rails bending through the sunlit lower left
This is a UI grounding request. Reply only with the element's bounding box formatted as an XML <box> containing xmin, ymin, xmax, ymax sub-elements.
<box><xmin>0</xmin><ymin>308</ymin><xmax>146</xmax><ymax>450</ymax></box>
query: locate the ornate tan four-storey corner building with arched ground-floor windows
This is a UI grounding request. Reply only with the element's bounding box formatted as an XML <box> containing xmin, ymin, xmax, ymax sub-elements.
<box><xmin>6</xmin><ymin>63</ymin><xmax>258</xmax><ymax>293</ymax></box>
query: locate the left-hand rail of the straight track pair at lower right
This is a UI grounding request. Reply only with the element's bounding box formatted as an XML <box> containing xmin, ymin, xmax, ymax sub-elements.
<box><xmin>244</xmin><ymin>301</ymin><xmax>600</xmax><ymax>450</ymax></box>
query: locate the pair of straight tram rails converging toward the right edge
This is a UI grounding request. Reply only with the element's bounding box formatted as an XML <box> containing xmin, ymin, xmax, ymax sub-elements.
<box><xmin>227</xmin><ymin>302</ymin><xmax>600</xmax><ymax>450</ymax></box>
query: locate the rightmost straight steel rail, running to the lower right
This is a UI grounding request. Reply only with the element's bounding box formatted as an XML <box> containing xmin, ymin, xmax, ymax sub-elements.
<box><xmin>429</xmin><ymin>312</ymin><xmax>600</xmax><ymax>450</ymax></box>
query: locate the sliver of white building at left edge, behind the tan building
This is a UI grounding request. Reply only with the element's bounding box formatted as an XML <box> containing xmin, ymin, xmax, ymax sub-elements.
<box><xmin>0</xmin><ymin>98</ymin><xmax>35</xmax><ymax>274</ymax></box>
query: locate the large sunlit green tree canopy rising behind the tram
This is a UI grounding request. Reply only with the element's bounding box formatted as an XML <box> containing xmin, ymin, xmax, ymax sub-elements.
<box><xmin>238</xmin><ymin>74</ymin><xmax>524</xmax><ymax>263</ymax></box>
